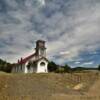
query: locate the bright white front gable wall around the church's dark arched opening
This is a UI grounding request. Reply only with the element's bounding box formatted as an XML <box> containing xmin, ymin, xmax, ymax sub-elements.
<box><xmin>36</xmin><ymin>59</ymin><xmax>48</xmax><ymax>73</ymax></box>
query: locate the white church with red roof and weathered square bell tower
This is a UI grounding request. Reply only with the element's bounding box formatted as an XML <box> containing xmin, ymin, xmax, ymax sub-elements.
<box><xmin>12</xmin><ymin>40</ymin><xmax>48</xmax><ymax>73</ymax></box>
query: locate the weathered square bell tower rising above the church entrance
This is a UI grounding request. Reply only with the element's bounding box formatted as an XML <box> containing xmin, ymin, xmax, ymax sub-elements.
<box><xmin>35</xmin><ymin>40</ymin><xmax>46</xmax><ymax>58</ymax></box>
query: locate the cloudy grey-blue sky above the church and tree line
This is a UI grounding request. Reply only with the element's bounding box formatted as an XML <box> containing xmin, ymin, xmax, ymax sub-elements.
<box><xmin>0</xmin><ymin>0</ymin><xmax>100</xmax><ymax>67</ymax></box>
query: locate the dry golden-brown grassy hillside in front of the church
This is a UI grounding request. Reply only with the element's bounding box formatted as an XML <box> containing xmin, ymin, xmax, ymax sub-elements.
<box><xmin>0</xmin><ymin>72</ymin><xmax>99</xmax><ymax>100</ymax></box>
